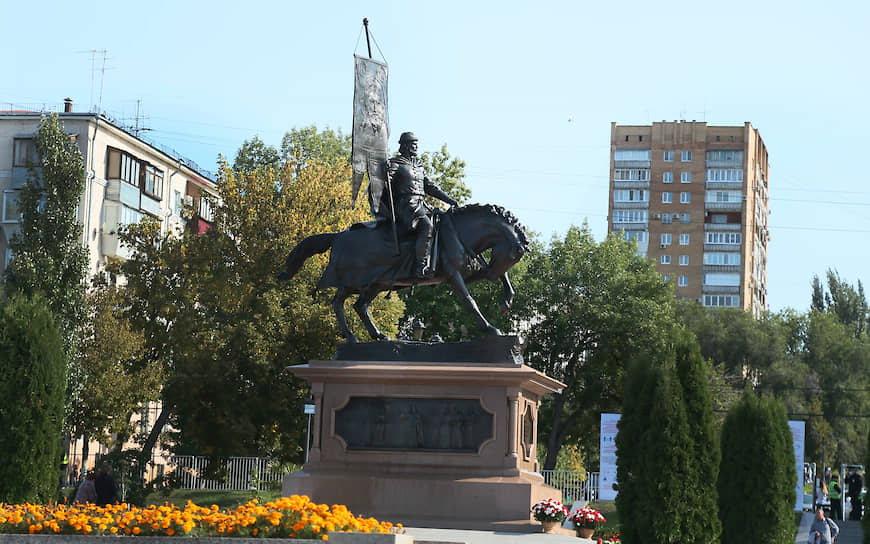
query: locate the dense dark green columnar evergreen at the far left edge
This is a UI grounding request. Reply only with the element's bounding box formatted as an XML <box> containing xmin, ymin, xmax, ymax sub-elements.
<box><xmin>0</xmin><ymin>295</ymin><xmax>66</xmax><ymax>503</ymax></box>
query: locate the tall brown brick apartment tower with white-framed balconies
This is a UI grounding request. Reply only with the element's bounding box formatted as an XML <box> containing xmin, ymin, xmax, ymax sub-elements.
<box><xmin>608</xmin><ymin>121</ymin><xmax>770</xmax><ymax>315</ymax></box>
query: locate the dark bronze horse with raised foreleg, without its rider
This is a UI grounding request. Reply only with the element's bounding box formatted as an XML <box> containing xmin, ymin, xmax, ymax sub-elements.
<box><xmin>279</xmin><ymin>204</ymin><xmax>528</xmax><ymax>342</ymax></box>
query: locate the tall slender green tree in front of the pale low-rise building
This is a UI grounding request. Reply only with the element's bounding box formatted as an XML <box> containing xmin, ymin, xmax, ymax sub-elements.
<box><xmin>6</xmin><ymin>114</ymin><xmax>88</xmax><ymax>422</ymax></box>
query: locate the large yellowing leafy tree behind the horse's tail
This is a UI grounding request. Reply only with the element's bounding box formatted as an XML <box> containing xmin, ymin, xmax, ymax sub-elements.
<box><xmin>122</xmin><ymin>130</ymin><xmax>402</xmax><ymax>470</ymax></box>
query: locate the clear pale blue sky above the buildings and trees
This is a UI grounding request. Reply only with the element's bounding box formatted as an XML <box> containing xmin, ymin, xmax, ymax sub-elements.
<box><xmin>0</xmin><ymin>0</ymin><xmax>870</xmax><ymax>311</ymax></box>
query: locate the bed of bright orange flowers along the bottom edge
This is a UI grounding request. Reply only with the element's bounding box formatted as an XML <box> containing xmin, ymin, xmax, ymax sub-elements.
<box><xmin>0</xmin><ymin>495</ymin><xmax>401</xmax><ymax>540</ymax></box>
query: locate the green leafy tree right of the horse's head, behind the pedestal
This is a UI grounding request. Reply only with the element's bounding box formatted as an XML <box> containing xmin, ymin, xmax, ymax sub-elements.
<box><xmin>515</xmin><ymin>226</ymin><xmax>673</xmax><ymax>469</ymax></box>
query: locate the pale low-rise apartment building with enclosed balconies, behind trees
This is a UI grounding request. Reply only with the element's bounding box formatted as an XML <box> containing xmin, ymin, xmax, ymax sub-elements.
<box><xmin>0</xmin><ymin>100</ymin><xmax>215</xmax><ymax>276</ymax></box>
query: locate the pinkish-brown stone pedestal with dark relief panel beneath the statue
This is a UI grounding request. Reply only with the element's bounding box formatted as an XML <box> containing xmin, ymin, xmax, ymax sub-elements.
<box><xmin>283</xmin><ymin>338</ymin><xmax>563</xmax><ymax>531</ymax></box>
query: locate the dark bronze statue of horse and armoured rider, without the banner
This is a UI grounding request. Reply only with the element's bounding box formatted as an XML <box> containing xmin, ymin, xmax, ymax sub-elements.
<box><xmin>279</xmin><ymin>132</ymin><xmax>528</xmax><ymax>343</ymax></box>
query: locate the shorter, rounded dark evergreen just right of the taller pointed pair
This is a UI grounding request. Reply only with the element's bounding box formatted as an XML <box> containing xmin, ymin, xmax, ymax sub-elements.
<box><xmin>718</xmin><ymin>389</ymin><xmax>797</xmax><ymax>544</ymax></box>
